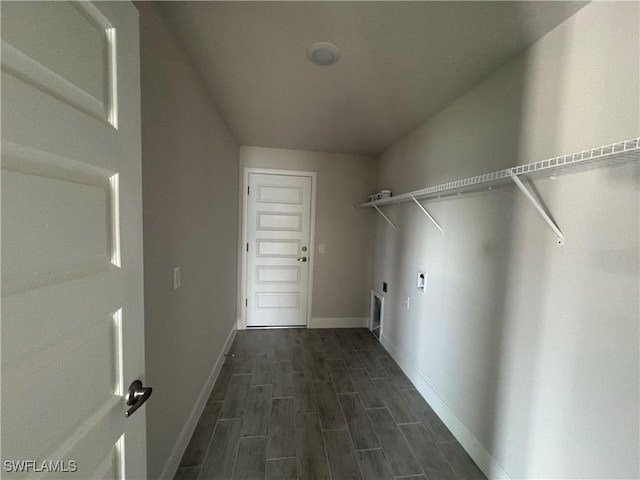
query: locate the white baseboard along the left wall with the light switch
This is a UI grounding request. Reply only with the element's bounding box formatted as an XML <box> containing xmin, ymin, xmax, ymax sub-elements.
<box><xmin>160</xmin><ymin>326</ymin><xmax>237</xmax><ymax>480</ymax></box>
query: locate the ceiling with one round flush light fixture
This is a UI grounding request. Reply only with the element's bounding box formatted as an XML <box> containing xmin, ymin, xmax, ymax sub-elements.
<box><xmin>161</xmin><ymin>1</ymin><xmax>585</xmax><ymax>154</ymax></box>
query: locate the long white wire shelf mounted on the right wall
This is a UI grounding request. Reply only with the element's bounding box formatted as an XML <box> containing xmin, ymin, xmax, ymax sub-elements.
<box><xmin>356</xmin><ymin>137</ymin><xmax>640</xmax><ymax>207</ymax></box>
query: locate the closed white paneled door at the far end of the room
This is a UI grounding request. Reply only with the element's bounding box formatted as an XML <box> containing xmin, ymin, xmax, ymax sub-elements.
<box><xmin>246</xmin><ymin>173</ymin><xmax>312</xmax><ymax>327</ymax></box>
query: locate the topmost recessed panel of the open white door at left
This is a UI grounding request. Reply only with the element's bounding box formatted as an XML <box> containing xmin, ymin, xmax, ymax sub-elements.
<box><xmin>2</xmin><ymin>2</ymin><xmax>117</xmax><ymax>127</ymax></box>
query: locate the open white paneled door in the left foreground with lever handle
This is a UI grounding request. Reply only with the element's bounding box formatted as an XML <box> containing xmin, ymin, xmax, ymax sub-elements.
<box><xmin>0</xmin><ymin>1</ymin><xmax>146</xmax><ymax>479</ymax></box>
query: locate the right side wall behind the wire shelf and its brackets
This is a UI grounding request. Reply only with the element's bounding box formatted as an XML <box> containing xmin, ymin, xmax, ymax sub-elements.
<box><xmin>373</xmin><ymin>2</ymin><xmax>640</xmax><ymax>478</ymax></box>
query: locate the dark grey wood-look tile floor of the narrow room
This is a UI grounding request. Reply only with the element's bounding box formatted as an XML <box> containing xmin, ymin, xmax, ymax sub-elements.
<box><xmin>175</xmin><ymin>328</ymin><xmax>485</xmax><ymax>480</ymax></box>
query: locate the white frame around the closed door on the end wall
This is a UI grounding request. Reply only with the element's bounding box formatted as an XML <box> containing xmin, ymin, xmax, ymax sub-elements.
<box><xmin>237</xmin><ymin>167</ymin><xmax>318</xmax><ymax>330</ymax></box>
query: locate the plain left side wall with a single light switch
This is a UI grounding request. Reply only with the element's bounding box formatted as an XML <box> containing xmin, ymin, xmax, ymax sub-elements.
<box><xmin>137</xmin><ymin>2</ymin><xmax>238</xmax><ymax>479</ymax></box>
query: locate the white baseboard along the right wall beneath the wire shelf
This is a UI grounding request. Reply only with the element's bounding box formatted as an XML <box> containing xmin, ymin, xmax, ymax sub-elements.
<box><xmin>380</xmin><ymin>334</ymin><xmax>511</xmax><ymax>480</ymax></box>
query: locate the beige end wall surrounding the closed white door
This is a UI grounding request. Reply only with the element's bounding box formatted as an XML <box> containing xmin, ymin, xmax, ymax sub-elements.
<box><xmin>238</xmin><ymin>147</ymin><xmax>377</xmax><ymax>326</ymax></box>
